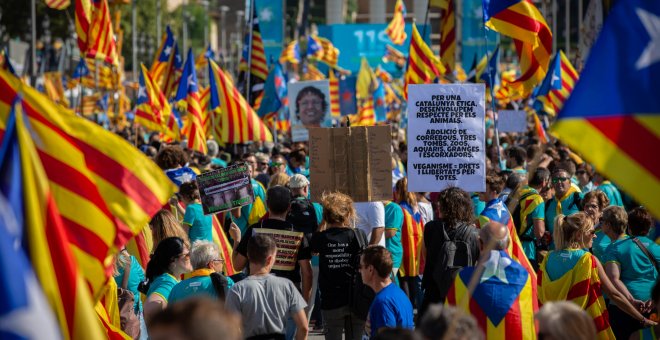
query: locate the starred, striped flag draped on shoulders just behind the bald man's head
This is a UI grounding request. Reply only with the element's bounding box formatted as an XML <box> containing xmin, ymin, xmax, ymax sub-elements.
<box><xmin>479</xmin><ymin>198</ymin><xmax>538</xmax><ymax>306</ymax></box>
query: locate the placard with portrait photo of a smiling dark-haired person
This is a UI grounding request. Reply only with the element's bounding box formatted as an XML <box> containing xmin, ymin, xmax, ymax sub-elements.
<box><xmin>288</xmin><ymin>80</ymin><xmax>332</xmax><ymax>142</ymax></box>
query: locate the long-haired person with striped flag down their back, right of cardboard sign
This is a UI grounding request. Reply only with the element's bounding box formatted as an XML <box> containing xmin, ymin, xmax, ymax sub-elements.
<box><xmin>394</xmin><ymin>177</ymin><xmax>424</xmax><ymax>306</ymax></box>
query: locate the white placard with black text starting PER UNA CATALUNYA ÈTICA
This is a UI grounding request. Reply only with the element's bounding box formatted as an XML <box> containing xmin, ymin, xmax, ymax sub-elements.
<box><xmin>407</xmin><ymin>84</ymin><xmax>486</xmax><ymax>192</ymax></box>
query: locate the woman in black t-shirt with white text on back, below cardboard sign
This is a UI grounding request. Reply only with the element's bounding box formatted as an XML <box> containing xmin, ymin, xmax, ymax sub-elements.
<box><xmin>311</xmin><ymin>192</ymin><xmax>368</xmax><ymax>340</ymax></box>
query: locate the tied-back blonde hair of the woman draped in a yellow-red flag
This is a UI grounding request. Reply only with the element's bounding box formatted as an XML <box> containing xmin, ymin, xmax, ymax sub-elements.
<box><xmin>552</xmin><ymin>212</ymin><xmax>594</xmax><ymax>249</ymax></box>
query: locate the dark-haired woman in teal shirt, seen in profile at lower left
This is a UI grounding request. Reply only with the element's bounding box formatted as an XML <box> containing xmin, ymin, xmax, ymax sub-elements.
<box><xmin>144</xmin><ymin>237</ymin><xmax>192</xmax><ymax>322</ymax></box>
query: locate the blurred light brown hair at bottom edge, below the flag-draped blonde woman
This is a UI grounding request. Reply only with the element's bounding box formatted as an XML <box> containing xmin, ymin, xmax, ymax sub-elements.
<box><xmin>536</xmin><ymin>301</ymin><xmax>596</xmax><ymax>340</ymax></box>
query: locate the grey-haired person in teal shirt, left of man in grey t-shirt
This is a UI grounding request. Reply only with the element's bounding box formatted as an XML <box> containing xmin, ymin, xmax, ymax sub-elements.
<box><xmin>169</xmin><ymin>240</ymin><xmax>234</xmax><ymax>303</ymax></box>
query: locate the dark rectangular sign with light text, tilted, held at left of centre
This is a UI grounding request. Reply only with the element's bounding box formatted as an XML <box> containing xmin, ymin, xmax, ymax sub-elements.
<box><xmin>197</xmin><ymin>163</ymin><xmax>254</xmax><ymax>215</ymax></box>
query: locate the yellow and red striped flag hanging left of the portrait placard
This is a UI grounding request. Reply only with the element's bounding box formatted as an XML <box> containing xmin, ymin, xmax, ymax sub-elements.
<box><xmin>209</xmin><ymin>60</ymin><xmax>273</xmax><ymax>143</ymax></box>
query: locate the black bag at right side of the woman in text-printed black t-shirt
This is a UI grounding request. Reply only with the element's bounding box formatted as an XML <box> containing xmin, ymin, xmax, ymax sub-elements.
<box><xmin>348</xmin><ymin>228</ymin><xmax>376</xmax><ymax>320</ymax></box>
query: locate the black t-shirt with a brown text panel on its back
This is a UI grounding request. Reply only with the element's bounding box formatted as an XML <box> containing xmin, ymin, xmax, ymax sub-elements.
<box><xmin>236</xmin><ymin>218</ymin><xmax>312</xmax><ymax>284</ymax></box>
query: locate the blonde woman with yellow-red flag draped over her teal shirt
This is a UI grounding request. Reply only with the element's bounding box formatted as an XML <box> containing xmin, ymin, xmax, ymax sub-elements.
<box><xmin>538</xmin><ymin>212</ymin><xmax>655</xmax><ymax>339</ymax></box>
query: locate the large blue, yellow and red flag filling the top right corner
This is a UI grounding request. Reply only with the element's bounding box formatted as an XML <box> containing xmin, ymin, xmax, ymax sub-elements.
<box><xmin>552</xmin><ymin>0</ymin><xmax>660</xmax><ymax>218</ymax></box>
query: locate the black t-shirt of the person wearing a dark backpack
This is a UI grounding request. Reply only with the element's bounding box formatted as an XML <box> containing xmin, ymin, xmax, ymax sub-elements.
<box><xmin>422</xmin><ymin>220</ymin><xmax>480</xmax><ymax>289</ymax></box>
